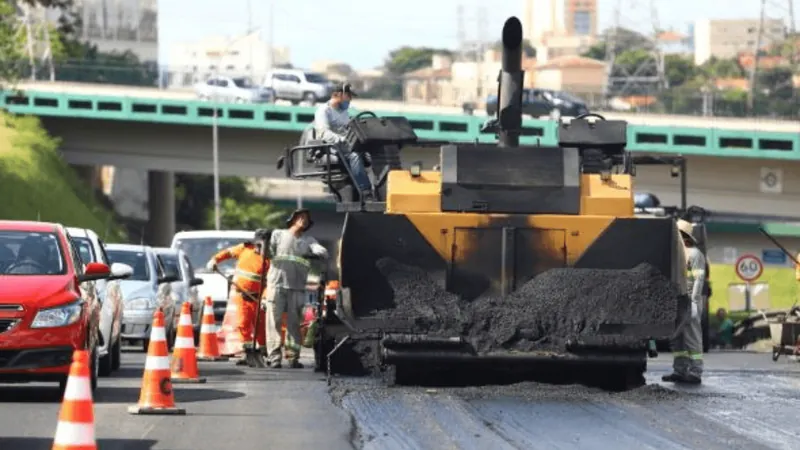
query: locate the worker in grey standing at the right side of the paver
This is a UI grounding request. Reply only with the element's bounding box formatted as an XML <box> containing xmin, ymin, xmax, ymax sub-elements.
<box><xmin>662</xmin><ymin>219</ymin><xmax>707</xmax><ymax>384</ymax></box>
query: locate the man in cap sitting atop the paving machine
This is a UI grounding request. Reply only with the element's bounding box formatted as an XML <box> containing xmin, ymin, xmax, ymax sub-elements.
<box><xmin>303</xmin><ymin>84</ymin><xmax>374</xmax><ymax>200</ymax></box>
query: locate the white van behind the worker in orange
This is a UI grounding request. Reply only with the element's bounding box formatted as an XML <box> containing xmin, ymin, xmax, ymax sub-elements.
<box><xmin>171</xmin><ymin>230</ymin><xmax>253</xmax><ymax>322</ymax></box>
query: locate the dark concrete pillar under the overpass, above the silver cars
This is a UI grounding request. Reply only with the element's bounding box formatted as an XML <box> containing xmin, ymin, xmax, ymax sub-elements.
<box><xmin>144</xmin><ymin>170</ymin><xmax>175</xmax><ymax>247</ymax></box>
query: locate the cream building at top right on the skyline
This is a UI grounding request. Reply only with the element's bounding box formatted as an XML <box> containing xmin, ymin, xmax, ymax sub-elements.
<box><xmin>694</xmin><ymin>19</ymin><xmax>786</xmax><ymax>65</ymax></box>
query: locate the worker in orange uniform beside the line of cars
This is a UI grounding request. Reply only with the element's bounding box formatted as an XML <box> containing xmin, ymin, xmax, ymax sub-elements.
<box><xmin>206</xmin><ymin>228</ymin><xmax>272</xmax><ymax>362</ymax></box>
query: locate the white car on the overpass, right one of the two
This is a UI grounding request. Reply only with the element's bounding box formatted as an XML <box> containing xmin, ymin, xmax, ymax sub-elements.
<box><xmin>264</xmin><ymin>69</ymin><xmax>334</xmax><ymax>105</ymax></box>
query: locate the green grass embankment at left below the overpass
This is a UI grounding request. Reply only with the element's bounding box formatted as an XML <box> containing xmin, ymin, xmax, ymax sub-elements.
<box><xmin>0</xmin><ymin>112</ymin><xmax>125</xmax><ymax>241</ymax></box>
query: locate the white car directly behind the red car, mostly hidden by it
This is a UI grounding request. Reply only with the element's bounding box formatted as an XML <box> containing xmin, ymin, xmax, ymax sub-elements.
<box><xmin>67</xmin><ymin>227</ymin><xmax>133</xmax><ymax>376</ymax></box>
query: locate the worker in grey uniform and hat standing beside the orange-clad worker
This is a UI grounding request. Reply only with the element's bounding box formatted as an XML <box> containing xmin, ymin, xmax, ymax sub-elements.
<box><xmin>264</xmin><ymin>209</ymin><xmax>328</xmax><ymax>369</ymax></box>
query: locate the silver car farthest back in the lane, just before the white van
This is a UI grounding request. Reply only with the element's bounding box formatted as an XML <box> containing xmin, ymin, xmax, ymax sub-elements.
<box><xmin>154</xmin><ymin>247</ymin><xmax>203</xmax><ymax>340</ymax></box>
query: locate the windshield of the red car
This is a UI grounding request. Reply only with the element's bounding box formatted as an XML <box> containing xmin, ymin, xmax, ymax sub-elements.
<box><xmin>0</xmin><ymin>231</ymin><xmax>67</xmax><ymax>275</ymax></box>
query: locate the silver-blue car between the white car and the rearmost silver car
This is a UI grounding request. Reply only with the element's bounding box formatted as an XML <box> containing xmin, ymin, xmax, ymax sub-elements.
<box><xmin>106</xmin><ymin>244</ymin><xmax>180</xmax><ymax>351</ymax></box>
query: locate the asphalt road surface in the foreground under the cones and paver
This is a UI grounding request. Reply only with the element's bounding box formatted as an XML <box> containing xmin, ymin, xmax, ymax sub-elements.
<box><xmin>0</xmin><ymin>353</ymin><xmax>800</xmax><ymax>450</ymax></box>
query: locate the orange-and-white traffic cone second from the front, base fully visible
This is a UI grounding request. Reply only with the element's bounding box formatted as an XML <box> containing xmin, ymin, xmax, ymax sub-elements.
<box><xmin>128</xmin><ymin>309</ymin><xmax>186</xmax><ymax>415</ymax></box>
